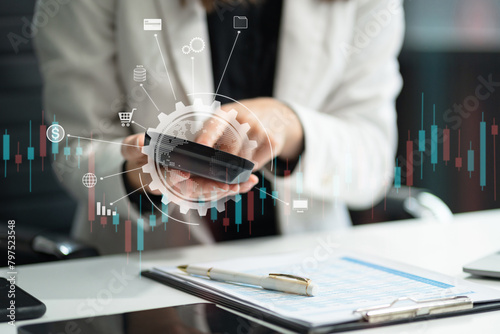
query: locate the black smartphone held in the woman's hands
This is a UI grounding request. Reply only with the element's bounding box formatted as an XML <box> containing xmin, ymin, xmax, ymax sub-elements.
<box><xmin>144</xmin><ymin>132</ymin><xmax>254</xmax><ymax>184</ymax></box>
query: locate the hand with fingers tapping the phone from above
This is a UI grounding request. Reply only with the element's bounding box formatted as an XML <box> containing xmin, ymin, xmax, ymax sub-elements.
<box><xmin>196</xmin><ymin>98</ymin><xmax>304</xmax><ymax>170</ymax></box>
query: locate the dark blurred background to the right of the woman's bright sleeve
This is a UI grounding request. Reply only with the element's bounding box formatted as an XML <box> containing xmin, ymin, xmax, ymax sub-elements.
<box><xmin>353</xmin><ymin>0</ymin><xmax>500</xmax><ymax>223</ymax></box>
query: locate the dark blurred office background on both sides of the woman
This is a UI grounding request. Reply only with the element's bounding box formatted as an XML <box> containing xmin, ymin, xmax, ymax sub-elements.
<box><xmin>0</xmin><ymin>0</ymin><xmax>500</xmax><ymax>232</ymax></box>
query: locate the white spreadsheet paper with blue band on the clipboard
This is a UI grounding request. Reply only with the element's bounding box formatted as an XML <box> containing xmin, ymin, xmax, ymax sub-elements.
<box><xmin>155</xmin><ymin>253</ymin><xmax>500</xmax><ymax>326</ymax></box>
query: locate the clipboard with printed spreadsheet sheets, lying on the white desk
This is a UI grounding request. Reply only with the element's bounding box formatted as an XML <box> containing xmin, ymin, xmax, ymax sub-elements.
<box><xmin>143</xmin><ymin>252</ymin><xmax>500</xmax><ymax>332</ymax></box>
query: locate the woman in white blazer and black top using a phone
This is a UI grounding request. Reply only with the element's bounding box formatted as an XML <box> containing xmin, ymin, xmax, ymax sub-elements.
<box><xmin>36</xmin><ymin>0</ymin><xmax>404</xmax><ymax>253</ymax></box>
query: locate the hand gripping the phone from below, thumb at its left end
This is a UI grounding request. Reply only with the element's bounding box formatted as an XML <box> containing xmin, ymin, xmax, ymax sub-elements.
<box><xmin>121</xmin><ymin>134</ymin><xmax>259</xmax><ymax>200</ymax></box>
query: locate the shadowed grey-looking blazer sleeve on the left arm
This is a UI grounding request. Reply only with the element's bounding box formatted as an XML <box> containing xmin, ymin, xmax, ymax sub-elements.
<box><xmin>35</xmin><ymin>0</ymin><xmax>136</xmax><ymax>219</ymax></box>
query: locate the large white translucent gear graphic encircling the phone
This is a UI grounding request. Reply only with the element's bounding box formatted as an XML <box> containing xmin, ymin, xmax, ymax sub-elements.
<box><xmin>142</xmin><ymin>99</ymin><xmax>257</xmax><ymax>216</ymax></box>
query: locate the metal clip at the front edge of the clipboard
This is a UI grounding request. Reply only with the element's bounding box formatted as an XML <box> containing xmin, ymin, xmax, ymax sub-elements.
<box><xmin>353</xmin><ymin>296</ymin><xmax>473</xmax><ymax>323</ymax></box>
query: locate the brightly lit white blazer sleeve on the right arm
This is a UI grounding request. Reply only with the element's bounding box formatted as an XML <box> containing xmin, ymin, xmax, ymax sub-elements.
<box><xmin>277</xmin><ymin>0</ymin><xmax>404</xmax><ymax>208</ymax></box>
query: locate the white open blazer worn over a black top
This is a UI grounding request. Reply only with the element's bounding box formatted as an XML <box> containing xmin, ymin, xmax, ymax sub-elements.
<box><xmin>35</xmin><ymin>0</ymin><xmax>404</xmax><ymax>253</ymax></box>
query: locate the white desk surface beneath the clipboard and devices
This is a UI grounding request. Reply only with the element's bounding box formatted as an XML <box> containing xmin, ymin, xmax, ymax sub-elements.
<box><xmin>0</xmin><ymin>210</ymin><xmax>500</xmax><ymax>334</ymax></box>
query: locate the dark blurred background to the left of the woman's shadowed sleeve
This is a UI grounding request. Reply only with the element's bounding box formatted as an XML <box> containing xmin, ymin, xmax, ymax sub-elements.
<box><xmin>0</xmin><ymin>0</ymin><xmax>76</xmax><ymax>232</ymax></box>
